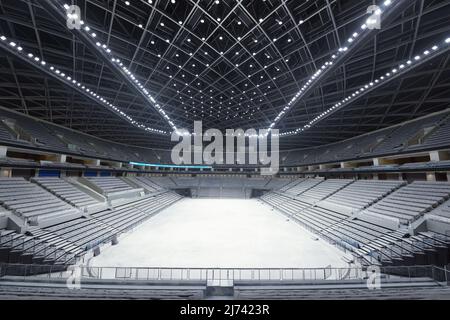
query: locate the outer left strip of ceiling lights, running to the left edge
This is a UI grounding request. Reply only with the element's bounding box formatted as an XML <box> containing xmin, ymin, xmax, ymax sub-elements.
<box><xmin>0</xmin><ymin>35</ymin><xmax>168</xmax><ymax>135</ymax></box>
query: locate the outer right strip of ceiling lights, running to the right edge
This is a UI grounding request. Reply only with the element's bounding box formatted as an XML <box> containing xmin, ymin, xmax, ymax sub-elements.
<box><xmin>280</xmin><ymin>37</ymin><xmax>450</xmax><ymax>136</ymax></box>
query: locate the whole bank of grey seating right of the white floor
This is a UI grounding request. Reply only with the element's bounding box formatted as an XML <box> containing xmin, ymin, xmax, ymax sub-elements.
<box><xmin>261</xmin><ymin>180</ymin><xmax>450</xmax><ymax>263</ymax></box>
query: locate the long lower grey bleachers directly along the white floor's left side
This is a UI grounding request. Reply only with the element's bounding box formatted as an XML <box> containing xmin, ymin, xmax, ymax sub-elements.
<box><xmin>0</xmin><ymin>192</ymin><xmax>181</xmax><ymax>265</ymax></box>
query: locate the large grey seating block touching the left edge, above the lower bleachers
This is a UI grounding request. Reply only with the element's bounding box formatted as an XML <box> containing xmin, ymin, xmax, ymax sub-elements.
<box><xmin>0</xmin><ymin>178</ymin><xmax>79</xmax><ymax>221</ymax></box>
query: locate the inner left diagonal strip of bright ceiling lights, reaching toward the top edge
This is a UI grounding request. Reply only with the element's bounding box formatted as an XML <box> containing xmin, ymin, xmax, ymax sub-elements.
<box><xmin>64</xmin><ymin>4</ymin><xmax>177</xmax><ymax>130</ymax></box>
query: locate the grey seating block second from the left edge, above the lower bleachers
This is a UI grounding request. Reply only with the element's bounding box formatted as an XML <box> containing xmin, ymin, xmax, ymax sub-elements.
<box><xmin>33</xmin><ymin>178</ymin><xmax>100</xmax><ymax>208</ymax></box>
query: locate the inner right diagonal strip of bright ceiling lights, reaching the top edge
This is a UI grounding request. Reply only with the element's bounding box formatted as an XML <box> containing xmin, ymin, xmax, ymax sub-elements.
<box><xmin>269</xmin><ymin>0</ymin><xmax>394</xmax><ymax>130</ymax></box>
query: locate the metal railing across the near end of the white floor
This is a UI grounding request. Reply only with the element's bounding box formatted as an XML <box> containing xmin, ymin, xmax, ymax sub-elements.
<box><xmin>0</xmin><ymin>264</ymin><xmax>442</xmax><ymax>283</ymax></box>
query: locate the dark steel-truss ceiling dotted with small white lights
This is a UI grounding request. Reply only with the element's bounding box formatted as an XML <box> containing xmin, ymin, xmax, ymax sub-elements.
<box><xmin>0</xmin><ymin>0</ymin><xmax>450</xmax><ymax>148</ymax></box>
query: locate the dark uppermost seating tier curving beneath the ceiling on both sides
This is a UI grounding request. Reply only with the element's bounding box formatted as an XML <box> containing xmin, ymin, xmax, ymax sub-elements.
<box><xmin>0</xmin><ymin>108</ymin><xmax>450</xmax><ymax>166</ymax></box>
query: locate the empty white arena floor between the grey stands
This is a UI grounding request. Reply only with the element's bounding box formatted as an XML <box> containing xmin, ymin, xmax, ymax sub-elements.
<box><xmin>91</xmin><ymin>199</ymin><xmax>346</xmax><ymax>268</ymax></box>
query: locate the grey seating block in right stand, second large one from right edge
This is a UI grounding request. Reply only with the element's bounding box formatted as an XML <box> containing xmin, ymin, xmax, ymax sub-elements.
<box><xmin>325</xmin><ymin>180</ymin><xmax>405</xmax><ymax>211</ymax></box>
